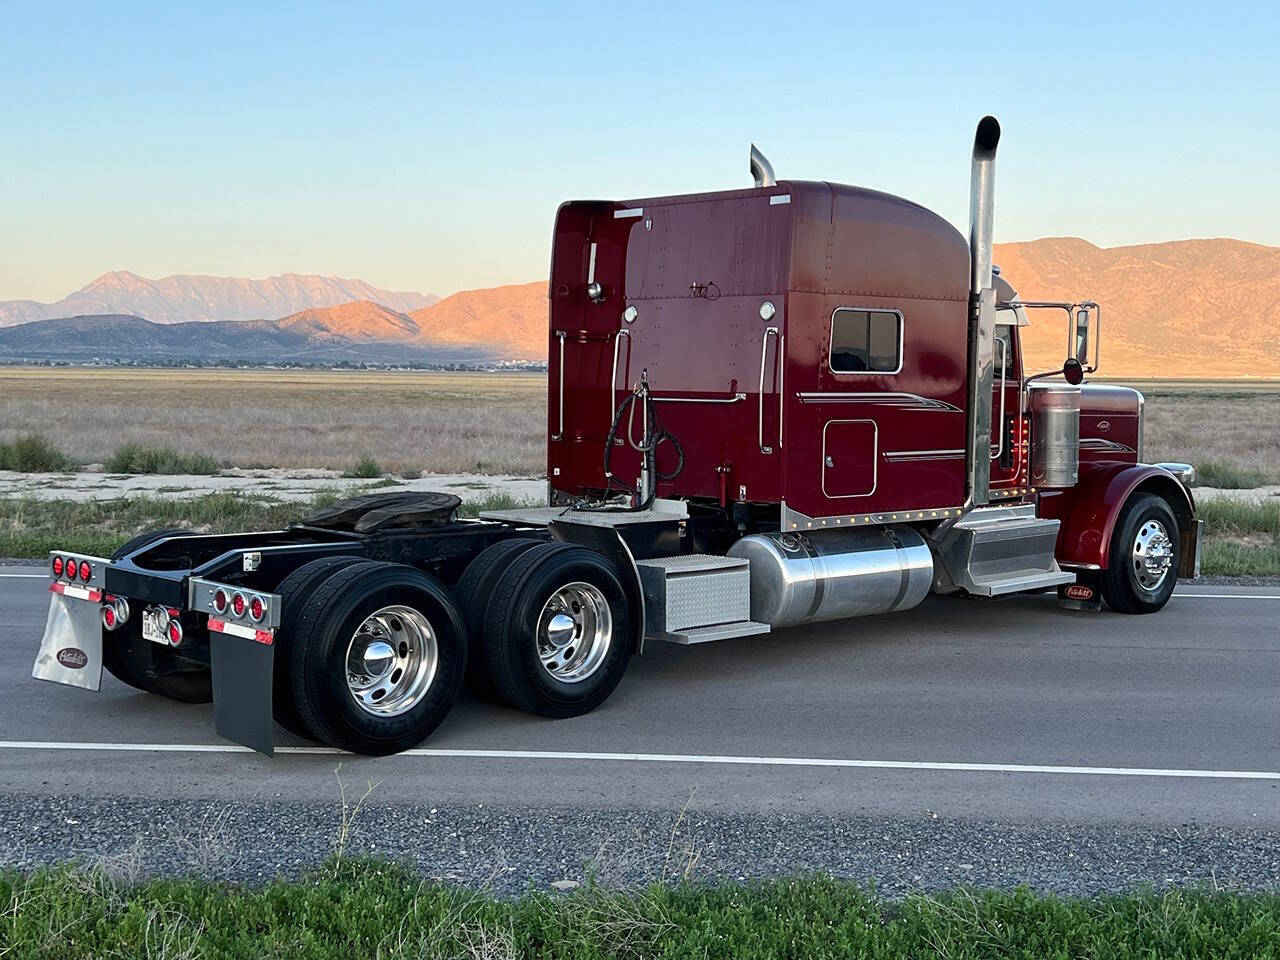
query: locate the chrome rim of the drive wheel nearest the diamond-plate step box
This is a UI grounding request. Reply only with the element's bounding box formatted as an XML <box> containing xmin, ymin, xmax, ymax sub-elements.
<box><xmin>538</xmin><ymin>582</ymin><xmax>613</xmax><ymax>684</ymax></box>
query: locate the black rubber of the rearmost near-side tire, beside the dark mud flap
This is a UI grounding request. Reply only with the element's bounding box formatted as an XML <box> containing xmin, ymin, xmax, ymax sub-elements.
<box><xmin>288</xmin><ymin>562</ymin><xmax>467</xmax><ymax>755</ymax></box>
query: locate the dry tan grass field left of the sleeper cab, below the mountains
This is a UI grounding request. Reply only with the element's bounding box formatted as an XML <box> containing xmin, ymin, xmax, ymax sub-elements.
<box><xmin>0</xmin><ymin>367</ymin><xmax>547</xmax><ymax>475</ymax></box>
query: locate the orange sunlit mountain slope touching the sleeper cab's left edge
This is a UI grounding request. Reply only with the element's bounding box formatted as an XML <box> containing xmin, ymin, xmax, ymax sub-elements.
<box><xmin>410</xmin><ymin>280</ymin><xmax>549</xmax><ymax>360</ymax></box>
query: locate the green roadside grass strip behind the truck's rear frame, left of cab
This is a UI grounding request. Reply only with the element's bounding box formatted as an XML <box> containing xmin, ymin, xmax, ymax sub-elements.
<box><xmin>0</xmin><ymin>490</ymin><xmax>527</xmax><ymax>560</ymax></box>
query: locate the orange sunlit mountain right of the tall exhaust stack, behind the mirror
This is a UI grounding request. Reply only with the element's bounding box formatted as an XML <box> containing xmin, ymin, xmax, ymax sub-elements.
<box><xmin>995</xmin><ymin>237</ymin><xmax>1280</xmax><ymax>378</ymax></box>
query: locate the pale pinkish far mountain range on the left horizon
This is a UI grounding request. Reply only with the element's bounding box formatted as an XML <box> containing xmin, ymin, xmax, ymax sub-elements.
<box><xmin>0</xmin><ymin>270</ymin><xmax>439</xmax><ymax>326</ymax></box>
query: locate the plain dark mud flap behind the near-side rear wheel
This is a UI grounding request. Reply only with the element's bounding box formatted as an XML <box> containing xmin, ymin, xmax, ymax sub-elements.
<box><xmin>209</xmin><ymin>634</ymin><xmax>275</xmax><ymax>756</ymax></box>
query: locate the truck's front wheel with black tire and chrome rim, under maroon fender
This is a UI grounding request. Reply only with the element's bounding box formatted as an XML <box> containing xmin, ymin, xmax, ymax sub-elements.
<box><xmin>1102</xmin><ymin>493</ymin><xmax>1179</xmax><ymax>613</ymax></box>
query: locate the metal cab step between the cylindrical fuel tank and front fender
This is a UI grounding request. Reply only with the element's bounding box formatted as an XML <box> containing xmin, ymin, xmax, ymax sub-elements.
<box><xmin>938</xmin><ymin>504</ymin><xmax>1075</xmax><ymax>596</ymax></box>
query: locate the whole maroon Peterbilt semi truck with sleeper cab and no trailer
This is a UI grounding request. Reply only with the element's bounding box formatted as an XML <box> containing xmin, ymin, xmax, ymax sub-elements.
<box><xmin>33</xmin><ymin>116</ymin><xmax>1201</xmax><ymax>754</ymax></box>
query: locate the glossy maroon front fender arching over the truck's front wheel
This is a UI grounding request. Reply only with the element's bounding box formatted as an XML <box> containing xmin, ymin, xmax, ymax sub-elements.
<box><xmin>1037</xmin><ymin>461</ymin><xmax>1196</xmax><ymax>570</ymax></box>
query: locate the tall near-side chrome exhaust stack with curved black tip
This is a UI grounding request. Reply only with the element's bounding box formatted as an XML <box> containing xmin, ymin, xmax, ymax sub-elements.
<box><xmin>964</xmin><ymin>116</ymin><xmax>1000</xmax><ymax>511</ymax></box>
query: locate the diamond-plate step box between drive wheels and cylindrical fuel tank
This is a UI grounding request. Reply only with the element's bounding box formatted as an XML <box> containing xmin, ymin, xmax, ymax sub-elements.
<box><xmin>636</xmin><ymin>553</ymin><xmax>768</xmax><ymax>644</ymax></box>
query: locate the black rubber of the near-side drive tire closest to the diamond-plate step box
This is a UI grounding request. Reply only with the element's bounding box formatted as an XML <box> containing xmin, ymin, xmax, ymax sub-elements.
<box><xmin>483</xmin><ymin>543</ymin><xmax>636</xmax><ymax>718</ymax></box>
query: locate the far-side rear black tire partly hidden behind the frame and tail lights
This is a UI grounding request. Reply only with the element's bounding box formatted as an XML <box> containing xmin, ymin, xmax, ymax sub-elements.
<box><xmin>102</xmin><ymin>530</ymin><xmax>214</xmax><ymax>703</ymax></box>
